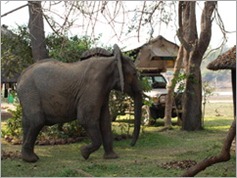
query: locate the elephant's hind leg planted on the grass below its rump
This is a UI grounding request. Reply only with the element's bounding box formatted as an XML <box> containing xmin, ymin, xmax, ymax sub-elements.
<box><xmin>21</xmin><ymin>113</ymin><xmax>44</xmax><ymax>162</ymax></box>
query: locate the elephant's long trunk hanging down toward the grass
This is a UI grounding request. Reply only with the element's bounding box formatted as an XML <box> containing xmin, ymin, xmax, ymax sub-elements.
<box><xmin>131</xmin><ymin>92</ymin><xmax>142</xmax><ymax>146</ymax></box>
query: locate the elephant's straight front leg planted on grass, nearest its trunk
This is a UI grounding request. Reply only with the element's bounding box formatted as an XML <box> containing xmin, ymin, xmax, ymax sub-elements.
<box><xmin>100</xmin><ymin>102</ymin><xmax>118</xmax><ymax>159</ymax></box>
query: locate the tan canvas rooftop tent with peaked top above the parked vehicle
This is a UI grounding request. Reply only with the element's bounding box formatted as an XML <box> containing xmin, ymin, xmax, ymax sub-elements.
<box><xmin>135</xmin><ymin>36</ymin><xmax>179</xmax><ymax>72</ymax></box>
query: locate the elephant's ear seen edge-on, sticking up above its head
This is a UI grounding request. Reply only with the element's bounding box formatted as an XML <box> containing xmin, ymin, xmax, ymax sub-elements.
<box><xmin>114</xmin><ymin>44</ymin><xmax>124</xmax><ymax>92</ymax></box>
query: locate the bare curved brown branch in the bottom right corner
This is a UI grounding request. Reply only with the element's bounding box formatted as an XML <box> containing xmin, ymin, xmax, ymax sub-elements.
<box><xmin>181</xmin><ymin>118</ymin><xmax>236</xmax><ymax>177</ymax></box>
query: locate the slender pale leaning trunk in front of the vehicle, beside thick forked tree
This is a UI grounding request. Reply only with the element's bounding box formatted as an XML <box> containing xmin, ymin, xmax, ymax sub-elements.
<box><xmin>164</xmin><ymin>45</ymin><xmax>183</xmax><ymax>128</ymax></box>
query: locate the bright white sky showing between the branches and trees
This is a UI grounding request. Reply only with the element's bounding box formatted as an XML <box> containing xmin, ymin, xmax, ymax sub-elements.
<box><xmin>1</xmin><ymin>1</ymin><xmax>236</xmax><ymax>50</ymax></box>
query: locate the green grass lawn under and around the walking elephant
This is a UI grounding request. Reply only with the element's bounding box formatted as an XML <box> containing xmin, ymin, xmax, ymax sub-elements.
<box><xmin>1</xmin><ymin>101</ymin><xmax>236</xmax><ymax>177</ymax></box>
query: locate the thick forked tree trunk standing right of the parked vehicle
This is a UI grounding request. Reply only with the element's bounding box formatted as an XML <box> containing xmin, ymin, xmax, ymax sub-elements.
<box><xmin>179</xmin><ymin>1</ymin><xmax>217</xmax><ymax>131</ymax></box>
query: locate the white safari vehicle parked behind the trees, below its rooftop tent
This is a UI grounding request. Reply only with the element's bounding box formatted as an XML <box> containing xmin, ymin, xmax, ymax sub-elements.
<box><xmin>141</xmin><ymin>73</ymin><xmax>182</xmax><ymax>125</ymax></box>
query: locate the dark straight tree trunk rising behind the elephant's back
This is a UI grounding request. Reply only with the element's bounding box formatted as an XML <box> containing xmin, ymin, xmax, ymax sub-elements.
<box><xmin>28</xmin><ymin>1</ymin><xmax>48</xmax><ymax>61</ymax></box>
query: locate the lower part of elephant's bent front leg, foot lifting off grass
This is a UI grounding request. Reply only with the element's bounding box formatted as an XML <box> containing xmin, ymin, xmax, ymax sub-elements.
<box><xmin>81</xmin><ymin>121</ymin><xmax>102</xmax><ymax>159</ymax></box>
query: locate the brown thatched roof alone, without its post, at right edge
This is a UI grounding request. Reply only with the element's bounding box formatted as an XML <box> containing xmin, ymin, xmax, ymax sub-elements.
<box><xmin>207</xmin><ymin>45</ymin><xmax>236</xmax><ymax>70</ymax></box>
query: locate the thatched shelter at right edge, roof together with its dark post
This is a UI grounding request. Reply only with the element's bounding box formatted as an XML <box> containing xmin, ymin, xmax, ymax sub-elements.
<box><xmin>207</xmin><ymin>45</ymin><xmax>236</xmax><ymax>116</ymax></box>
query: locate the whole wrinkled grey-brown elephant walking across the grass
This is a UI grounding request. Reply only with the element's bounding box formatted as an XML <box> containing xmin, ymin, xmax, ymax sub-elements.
<box><xmin>17</xmin><ymin>45</ymin><xmax>142</xmax><ymax>162</ymax></box>
